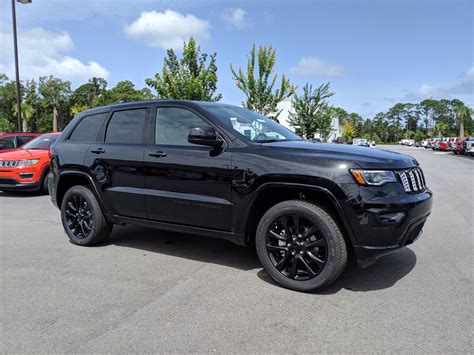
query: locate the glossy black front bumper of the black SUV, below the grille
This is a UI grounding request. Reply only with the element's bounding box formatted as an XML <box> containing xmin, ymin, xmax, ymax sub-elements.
<box><xmin>343</xmin><ymin>184</ymin><xmax>433</xmax><ymax>267</ymax></box>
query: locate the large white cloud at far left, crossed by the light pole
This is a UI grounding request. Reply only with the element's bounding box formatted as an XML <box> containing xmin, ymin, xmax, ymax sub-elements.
<box><xmin>0</xmin><ymin>27</ymin><xmax>109</xmax><ymax>82</ymax></box>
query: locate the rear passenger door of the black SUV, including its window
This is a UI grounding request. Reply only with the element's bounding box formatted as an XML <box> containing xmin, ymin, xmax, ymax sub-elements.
<box><xmin>86</xmin><ymin>106</ymin><xmax>150</xmax><ymax>218</ymax></box>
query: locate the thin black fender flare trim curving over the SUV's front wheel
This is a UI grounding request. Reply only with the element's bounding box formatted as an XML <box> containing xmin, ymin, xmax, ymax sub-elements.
<box><xmin>244</xmin><ymin>182</ymin><xmax>357</xmax><ymax>249</ymax></box>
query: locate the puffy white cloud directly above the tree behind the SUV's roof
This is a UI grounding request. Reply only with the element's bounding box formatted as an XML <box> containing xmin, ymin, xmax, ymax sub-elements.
<box><xmin>124</xmin><ymin>10</ymin><xmax>211</xmax><ymax>50</ymax></box>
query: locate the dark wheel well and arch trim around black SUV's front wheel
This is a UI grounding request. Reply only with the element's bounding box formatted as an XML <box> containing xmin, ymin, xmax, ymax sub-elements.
<box><xmin>245</xmin><ymin>182</ymin><xmax>356</xmax><ymax>248</ymax></box>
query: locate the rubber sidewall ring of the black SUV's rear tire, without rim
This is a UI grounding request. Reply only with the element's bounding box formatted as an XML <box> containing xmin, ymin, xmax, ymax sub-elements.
<box><xmin>61</xmin><ymin>186</ymin><xmax>97</xmax><ymax>246</ymax></box>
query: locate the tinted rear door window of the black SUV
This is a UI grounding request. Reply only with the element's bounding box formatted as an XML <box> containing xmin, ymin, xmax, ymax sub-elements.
<box><xmin>105</xmin><ymin>108</ymin><xmax>148</xmax><ymax>144</ymax></box>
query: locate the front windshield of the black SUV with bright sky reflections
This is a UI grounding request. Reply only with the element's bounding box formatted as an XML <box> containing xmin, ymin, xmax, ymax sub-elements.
<box><xmin>205</xmin><ymin>105</ymin><xmax>301</xmax><ymax>143</ymax></box>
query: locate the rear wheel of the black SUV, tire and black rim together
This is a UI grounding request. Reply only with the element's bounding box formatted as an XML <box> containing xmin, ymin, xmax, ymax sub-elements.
<box><xmin>61</xmin><ymin>185</ymin><xmax>113</xmax><ymax>246</ymax></box>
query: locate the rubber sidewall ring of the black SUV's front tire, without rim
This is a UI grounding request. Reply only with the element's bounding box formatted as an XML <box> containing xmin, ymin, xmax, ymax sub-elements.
<box><xmin>256</xmin><ymin>205</ymin><xmax>342</xmax><ymax>291</ymax></box>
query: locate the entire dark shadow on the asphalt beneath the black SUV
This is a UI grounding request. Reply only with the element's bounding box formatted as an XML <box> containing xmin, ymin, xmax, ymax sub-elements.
<box><xmin>103</xmin><ymin>225</ymin><xmax>416</xmax><ymax>295</ymax></box>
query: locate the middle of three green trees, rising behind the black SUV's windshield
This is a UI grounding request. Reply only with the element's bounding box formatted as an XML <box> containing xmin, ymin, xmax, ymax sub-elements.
<box><xmin>230</xmin><ymin>45</ymin><xmax>296</xmax><ymax>120</ymax></box>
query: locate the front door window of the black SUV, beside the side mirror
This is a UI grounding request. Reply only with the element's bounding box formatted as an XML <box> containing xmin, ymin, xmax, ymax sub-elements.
<box><xmin>155</xmin><ymin>107</ymin><xmax>208</xmax><ymax>146</ymax></box>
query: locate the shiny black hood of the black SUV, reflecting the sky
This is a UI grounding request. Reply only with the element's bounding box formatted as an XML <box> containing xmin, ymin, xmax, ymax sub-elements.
<box><xmin>262</xmin><ymin>141</ymin><xmax>418</xmax><ymax>169</ymax></box>
